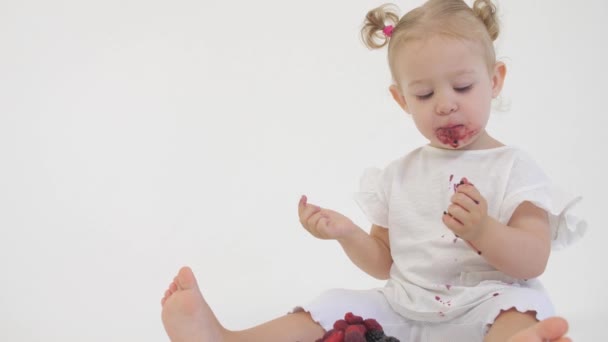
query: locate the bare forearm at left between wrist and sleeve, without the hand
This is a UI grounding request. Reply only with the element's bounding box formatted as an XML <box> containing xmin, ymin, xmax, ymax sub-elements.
<box><xmin>338</xmin><ymin>225</ymin><xmax>393</xmax><ymax>280</ymax></box>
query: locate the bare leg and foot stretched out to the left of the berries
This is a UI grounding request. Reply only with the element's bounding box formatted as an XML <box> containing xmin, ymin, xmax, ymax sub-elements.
<box><xmin>161</xmin><ymin>267</ymin><xmax>324</xmax><ymax>342</ymax></box>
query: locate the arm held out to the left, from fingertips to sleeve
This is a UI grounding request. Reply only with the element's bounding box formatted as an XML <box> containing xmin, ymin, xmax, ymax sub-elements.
<box><xmin>298</xmin><ymin>196</ymin><xmax>393</xmax><ymax>279</ymax></box>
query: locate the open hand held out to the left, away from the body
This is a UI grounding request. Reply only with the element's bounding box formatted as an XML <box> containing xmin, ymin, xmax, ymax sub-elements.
<box><xmin>298</xmin><ymin>196</ymin><xmax>357</xmax><ymax>240</ymax></box>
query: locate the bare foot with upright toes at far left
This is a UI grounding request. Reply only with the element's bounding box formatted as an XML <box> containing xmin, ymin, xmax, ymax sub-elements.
<box><xmin>161</xmin><ymin>267</ymin><xmax>224</xmax><ymax>342</ymax></box>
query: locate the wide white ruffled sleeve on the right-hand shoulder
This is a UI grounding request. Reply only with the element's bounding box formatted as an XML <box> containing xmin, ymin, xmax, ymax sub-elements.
<box><xmin>498</xmin><ymin>151</ymin><xmax>587</xmax><ymax>249</ymax></box>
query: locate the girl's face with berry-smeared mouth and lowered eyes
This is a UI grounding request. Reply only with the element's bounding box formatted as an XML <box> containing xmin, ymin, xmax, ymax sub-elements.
<box><xmin>391</xmin><ymin>36</ymin><xmax>505</xmax><ymax>149</ymax></box>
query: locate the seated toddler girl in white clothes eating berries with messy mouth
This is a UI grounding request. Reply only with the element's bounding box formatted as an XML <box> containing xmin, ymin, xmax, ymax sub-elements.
<box><xmin>162</xmin><ymin>0</ymin><xmax>585</xmax><ymax>342</ymax></box>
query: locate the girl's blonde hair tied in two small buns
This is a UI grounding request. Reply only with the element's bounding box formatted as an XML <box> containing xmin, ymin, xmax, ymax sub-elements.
<box><xmin>361</xmin><ymin>0</ymin><xmax>499</xmax><ymax>79</ymax></box>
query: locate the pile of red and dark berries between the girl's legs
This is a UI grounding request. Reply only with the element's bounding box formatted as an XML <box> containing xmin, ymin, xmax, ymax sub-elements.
<box><xmin>316</xmin><ymin>312</ymin><xmax>399</xmax><ymax>342</ymax></box>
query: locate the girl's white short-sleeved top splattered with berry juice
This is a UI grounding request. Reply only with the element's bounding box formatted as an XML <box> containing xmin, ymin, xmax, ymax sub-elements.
<box><xmin>355</xmin><ymin>145</ymin><xmax>586</xmax><ymax>322</ymax></box>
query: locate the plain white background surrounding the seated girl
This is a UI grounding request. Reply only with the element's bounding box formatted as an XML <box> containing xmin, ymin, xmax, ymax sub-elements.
<box><xmin>0</xmin><ymin>0</ymin><xmax>608</xmax><ymax>342</ymax></box>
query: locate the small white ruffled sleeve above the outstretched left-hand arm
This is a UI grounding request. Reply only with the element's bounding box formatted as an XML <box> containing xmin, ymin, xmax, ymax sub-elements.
<box><xmin>354</xmin><ymin>168</ymin><xmax>388</xmax><ymax>228</ymax></box>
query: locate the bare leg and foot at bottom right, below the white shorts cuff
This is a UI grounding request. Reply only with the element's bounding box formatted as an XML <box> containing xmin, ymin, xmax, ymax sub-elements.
<box><xmin>484</xmin><ymin>309</ymin><xmax>570</xmax><ymax>342</ymax></box>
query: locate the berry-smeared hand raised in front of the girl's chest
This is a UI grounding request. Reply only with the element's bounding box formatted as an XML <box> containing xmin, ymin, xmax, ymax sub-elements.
<box><xmin>442</xmin><ymin>178</ymin><xmax>488</xmax><ymax>241</ymax></box>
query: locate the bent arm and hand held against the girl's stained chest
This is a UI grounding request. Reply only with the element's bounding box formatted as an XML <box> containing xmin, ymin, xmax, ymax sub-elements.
<box><xmin>443</xmin><ymin>180</ymin><xmax>551</xmax><ymax>279</ymax></box>
